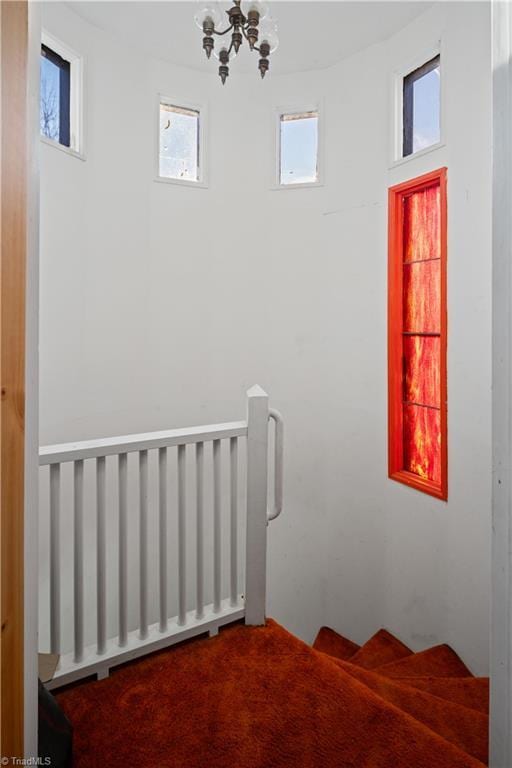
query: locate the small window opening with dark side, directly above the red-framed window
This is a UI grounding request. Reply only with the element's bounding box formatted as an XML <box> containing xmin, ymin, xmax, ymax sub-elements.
<box><xmin>402</xmin><ymin>55</ymin><xmax>441</xmax><ymax>157</ymax></box>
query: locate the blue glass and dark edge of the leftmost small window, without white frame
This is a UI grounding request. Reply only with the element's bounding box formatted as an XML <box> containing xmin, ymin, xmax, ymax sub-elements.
<box><xmin>40</xmin><ymin>45</ymin><xmax>71</xmax><ymax>147</ymax></box>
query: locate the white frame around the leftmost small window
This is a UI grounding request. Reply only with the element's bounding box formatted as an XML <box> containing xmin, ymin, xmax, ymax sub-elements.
<box><xmin>41</xmin><ymin>29</ymin><xmax>85</xmax><ymax>160</ymax></box>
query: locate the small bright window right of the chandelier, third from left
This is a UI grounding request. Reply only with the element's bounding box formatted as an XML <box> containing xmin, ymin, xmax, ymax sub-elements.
<box><xmin>278</xmin><ymin>111</ymin><xmax>319</xmax><ymax>186</ymax></box>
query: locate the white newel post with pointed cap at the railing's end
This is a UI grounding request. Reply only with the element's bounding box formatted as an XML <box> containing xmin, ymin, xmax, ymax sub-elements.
<box><xmin>245</xmin><ymin>386</ymin><xmax>268</xmax><ymax>624</ymax></box>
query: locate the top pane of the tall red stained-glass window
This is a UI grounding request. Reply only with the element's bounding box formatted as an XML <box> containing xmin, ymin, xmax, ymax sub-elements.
<box><xmin>403</xmin><ymin>185</ymin><xmax>441</xmax><ymax>262</ymax></box>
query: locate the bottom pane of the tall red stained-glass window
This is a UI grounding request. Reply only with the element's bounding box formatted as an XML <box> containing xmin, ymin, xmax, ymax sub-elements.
<box><xmin>403</xmin><ymin>405</ymin><xmax>441</xmax><ymax>483</ymax></box>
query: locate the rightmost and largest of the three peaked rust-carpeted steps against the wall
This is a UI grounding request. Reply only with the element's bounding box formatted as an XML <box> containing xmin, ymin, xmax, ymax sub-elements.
<box><xmin>376</xmin><ymin>644</ymin><xmax>473</xmax><ymax>677</ymax></box>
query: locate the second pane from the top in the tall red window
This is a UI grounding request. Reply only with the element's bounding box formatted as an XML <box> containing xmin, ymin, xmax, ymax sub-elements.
<box><xmin>403</xmin><ymin>259</ymin><xmax>441</xmax><ymax>333</ymax></box>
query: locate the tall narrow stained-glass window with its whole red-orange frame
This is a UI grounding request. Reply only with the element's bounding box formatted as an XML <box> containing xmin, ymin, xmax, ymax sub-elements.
<box><xmin>388</xmin><ymin>168</ymin><xmax>448</xmax><ymax>499</ymax></box>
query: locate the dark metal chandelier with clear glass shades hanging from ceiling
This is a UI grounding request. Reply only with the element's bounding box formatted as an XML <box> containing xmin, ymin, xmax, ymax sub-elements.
<box><xmin>195</xmin><ymin>0</ymin><xmax>279</xmax><ymax>85</ymax></box>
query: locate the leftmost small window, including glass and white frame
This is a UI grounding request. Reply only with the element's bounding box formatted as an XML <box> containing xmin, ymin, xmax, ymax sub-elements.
<box><xmin>39</xmin><ymin>33</ymin><xmax>82</xmax><ymax>153</ymax></box>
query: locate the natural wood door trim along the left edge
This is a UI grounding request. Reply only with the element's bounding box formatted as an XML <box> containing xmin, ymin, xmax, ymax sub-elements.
<box><xmin>0</xmin><ymin>0</ymin><xmax>28</xmax><ymax>758</ymax></box>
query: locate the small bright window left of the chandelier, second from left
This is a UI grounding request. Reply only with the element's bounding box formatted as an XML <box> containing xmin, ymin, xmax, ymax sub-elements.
<box><xmin>158</xmin><ymin>102</ymin><xmax>202</xmax><ymax>182</ymax></box>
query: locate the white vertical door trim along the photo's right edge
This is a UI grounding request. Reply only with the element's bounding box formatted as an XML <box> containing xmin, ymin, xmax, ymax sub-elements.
<box><xmin>489</xmin><ymin>3</ymin><xmax>512</xmax><ymax>768</ymax></box>
